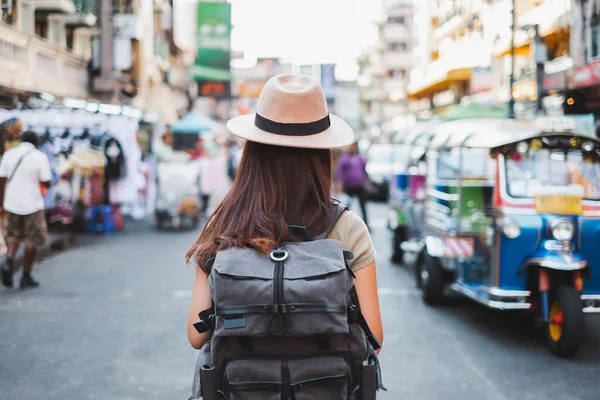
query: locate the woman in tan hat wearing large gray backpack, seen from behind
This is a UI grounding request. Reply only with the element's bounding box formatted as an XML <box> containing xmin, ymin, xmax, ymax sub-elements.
<box><xmin>187</xmin><ymin>74</ymin><xmax>383</xmax><ymax>400</ymax></box>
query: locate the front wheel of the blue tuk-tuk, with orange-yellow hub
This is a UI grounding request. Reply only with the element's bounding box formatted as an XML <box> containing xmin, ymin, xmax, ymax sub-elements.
<box><xmin>546</xmin><ymin>285</ymin><xmax>584</xmax><ymax>357</ymax></box>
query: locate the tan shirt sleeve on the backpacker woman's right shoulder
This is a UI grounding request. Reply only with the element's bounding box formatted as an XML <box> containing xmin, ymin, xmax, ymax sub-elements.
<box><xmin>327</xmin><ymin>211</ymin><xmax>377</xmax><ymax>271</ymax></box>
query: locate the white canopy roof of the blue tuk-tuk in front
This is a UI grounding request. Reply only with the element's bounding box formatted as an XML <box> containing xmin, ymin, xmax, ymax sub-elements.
<box><xmin>429</xmin><ymin>118</ymin><xmax>539</xmax><ymax>149</ymax></box>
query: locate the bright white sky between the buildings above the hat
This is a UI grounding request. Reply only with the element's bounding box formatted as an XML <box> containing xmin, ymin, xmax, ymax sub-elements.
<box><xmin>175</xmin><ymin>0</ymin><xmax>383</xmax><ymax>79</ymax></box>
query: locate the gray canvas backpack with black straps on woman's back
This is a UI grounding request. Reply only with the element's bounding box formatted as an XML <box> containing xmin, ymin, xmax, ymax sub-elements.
<box><xmin>190</xmin><ymin>202</ymin><xmax>385</xmax><ymax>400</ymax></box>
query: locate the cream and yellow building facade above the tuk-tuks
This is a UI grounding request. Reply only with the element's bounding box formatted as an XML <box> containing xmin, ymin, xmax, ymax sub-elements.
<box><xmin>409</xmin><ymin>0</ymin><xmax>573</xmax><ymax>119</ymax></box>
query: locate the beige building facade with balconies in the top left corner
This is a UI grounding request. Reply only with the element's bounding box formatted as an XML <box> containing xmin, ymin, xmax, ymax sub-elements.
<box><xmin>0</xmin><ymin>0</ymin><xmax>98</xmax><ymax>107</ymax></box>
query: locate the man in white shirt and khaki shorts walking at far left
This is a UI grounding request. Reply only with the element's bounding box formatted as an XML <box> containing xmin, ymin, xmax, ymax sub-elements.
<box><xmin>0</xmin><ymin>131</ymin><xmax>52</xmax><ymax>289</ymax></box>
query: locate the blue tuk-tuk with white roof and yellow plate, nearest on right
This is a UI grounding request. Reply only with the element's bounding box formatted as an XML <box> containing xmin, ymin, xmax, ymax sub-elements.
<box><xmin>417</xmin><ymin>119</ymin><xmax>600</xmax><ymax>357</ymax></box>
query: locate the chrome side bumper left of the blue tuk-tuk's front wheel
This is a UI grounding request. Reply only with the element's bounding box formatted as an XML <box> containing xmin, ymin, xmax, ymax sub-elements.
<box><xmin>450</xmin><ymin>283</ymin><xmax>531</xmax><ymax>310</ymax></box>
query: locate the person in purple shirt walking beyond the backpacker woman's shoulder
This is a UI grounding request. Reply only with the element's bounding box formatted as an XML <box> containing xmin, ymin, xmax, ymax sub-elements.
<box><xmin>336</xmin><ymin>143</ymin><xmax>369</xmax><ymax>226</ymax></box>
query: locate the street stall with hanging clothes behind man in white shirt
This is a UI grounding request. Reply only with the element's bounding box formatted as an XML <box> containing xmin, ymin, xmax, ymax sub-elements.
<box><xmin>0</xmin><ymin>99</ymin><xmax>153</xmax><ymax>248</ymax></box>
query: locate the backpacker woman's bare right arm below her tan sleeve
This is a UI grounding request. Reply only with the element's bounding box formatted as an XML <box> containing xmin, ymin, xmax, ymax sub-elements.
<box><xmin>354</xmin><ymin>261</ymin><xmax>383</xmax><ymax>352</ymax></box>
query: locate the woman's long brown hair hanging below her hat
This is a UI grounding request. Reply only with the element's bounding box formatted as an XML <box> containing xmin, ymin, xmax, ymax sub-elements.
<box><xmin>186</xmin><ymin>142</ymin><xmax>332</xmax><ymax>273</ymax></box>
